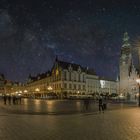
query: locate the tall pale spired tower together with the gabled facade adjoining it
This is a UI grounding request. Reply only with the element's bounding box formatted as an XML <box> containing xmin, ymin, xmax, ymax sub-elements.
<box><xmin>118</xmin><ymin>32</ymin><xmax>139</xmax><ymax>100</ymax></box>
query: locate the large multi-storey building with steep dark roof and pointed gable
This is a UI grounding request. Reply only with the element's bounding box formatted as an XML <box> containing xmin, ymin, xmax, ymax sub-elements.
<box><xmin>51</xmin><ymin>60</ymin><xmax>100</xmax><ymax>95</ymax></box>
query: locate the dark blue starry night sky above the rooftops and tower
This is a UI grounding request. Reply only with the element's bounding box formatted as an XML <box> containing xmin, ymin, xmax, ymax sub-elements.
<box><xmin>0</xmin><ymin>0</ymin><xmax>140</xmax><ymax>81</ymax></box>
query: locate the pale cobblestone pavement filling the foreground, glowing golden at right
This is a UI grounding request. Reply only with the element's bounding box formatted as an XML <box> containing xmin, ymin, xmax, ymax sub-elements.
<box><xmin>0</xmin><ymin>107</ymin><xmax>140</xmax><ymax>140</ymax></box>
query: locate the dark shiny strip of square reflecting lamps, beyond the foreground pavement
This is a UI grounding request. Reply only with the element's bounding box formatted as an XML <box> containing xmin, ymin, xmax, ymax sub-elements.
<box><xmin>0</xmin><ymin>99</ymin><xmax>137</xmax><ymax>115</ymax></box>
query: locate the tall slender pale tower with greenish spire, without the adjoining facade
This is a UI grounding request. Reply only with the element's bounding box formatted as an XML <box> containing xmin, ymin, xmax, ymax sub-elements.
<box><xmin>120</xmin><ymin>32</ymin><xmax>132</xmax><ymax>96</ymax></box>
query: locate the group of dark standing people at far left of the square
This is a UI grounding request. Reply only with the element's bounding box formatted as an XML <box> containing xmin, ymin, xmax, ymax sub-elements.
<box><xmin>3</xmin><ymin>95</ymin><xmax>21</xmax><ymax>105</ymax></box>
